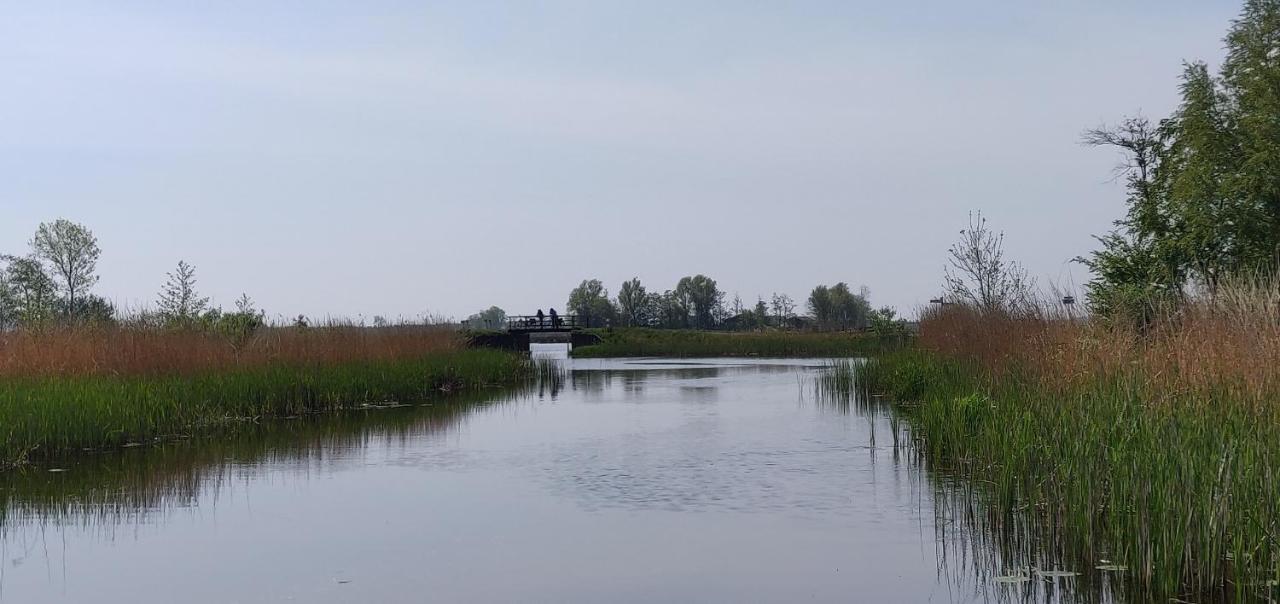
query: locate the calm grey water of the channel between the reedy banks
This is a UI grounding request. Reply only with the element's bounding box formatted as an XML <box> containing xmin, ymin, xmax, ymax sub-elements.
<box><xmin>0</xmin><ymin>350</ymin><xmax>1080</xmax><ymax>603</ymax></box>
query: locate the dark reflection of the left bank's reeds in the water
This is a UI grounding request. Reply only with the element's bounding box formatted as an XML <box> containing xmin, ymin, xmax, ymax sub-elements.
<box><xmin>0</xmin><ymin>392</ymin><xmax>513</xmax><ymax>536</ymax></box>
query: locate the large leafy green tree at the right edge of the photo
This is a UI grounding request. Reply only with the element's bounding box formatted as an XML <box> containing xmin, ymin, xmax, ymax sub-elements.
<box><xmin>1079</xmin><ymin>0</ymin><xmax>1280</xmax><ymax>318</ymax></box>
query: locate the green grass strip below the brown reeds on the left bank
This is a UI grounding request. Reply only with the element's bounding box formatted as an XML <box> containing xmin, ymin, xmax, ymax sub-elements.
<box><xmin>0</xmin><ymin>349</ymin><xmax>532</xmax><ymax>467</ymax></box>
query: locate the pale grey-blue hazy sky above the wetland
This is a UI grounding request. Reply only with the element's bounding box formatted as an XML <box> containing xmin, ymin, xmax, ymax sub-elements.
<box><xmin>0</xmin><ymin>0</ymin><xmax>1239</xmax><ymax>317</ymax></box>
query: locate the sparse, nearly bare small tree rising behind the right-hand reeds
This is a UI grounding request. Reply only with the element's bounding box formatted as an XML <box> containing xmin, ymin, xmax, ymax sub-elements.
<box><xmin>945</xmin><ymin>212</ymin><xmax>1034</xmax><ymax>312</ymax></box>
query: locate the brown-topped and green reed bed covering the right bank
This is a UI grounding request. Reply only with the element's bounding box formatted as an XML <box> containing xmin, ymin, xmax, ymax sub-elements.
<box><xmin>832</xmin><ymin>282</ymin><xmax>1280</xmax><ymax>601</ymax></box>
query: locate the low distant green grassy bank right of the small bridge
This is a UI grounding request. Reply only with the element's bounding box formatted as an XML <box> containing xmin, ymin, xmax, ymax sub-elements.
<box><xmin>573</xmin><ymin>328</ymin><xmax>897</xmax><ymax>357</ymax></box>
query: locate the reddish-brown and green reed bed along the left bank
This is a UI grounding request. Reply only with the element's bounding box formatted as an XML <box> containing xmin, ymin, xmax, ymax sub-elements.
<box><xmin>0</xmin><ymin>325</ymin><xmax>531</xmax><ymax>466</ymax></box>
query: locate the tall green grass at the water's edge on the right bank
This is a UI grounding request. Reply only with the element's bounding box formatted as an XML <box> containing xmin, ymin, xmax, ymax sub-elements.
<box><xmin>824</xmin><ymin>351</ymin><xmax>1280</xmax><ymax>601</ymax></box>
